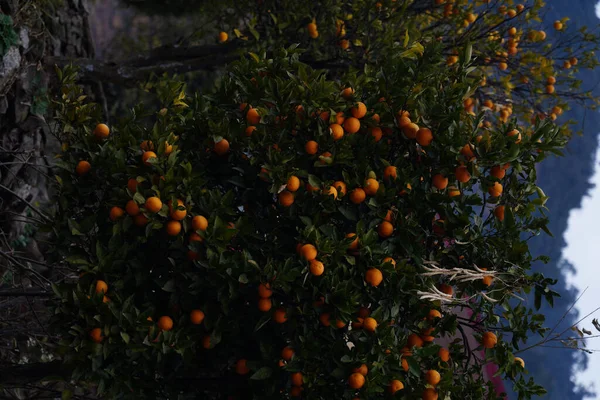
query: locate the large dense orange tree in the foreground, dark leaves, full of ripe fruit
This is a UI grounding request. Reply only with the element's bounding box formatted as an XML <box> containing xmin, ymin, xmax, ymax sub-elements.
<box><xmin>49</xmin><ymin>25</ymin><xmax>566</xmax><ymax>399</ymax></box>
